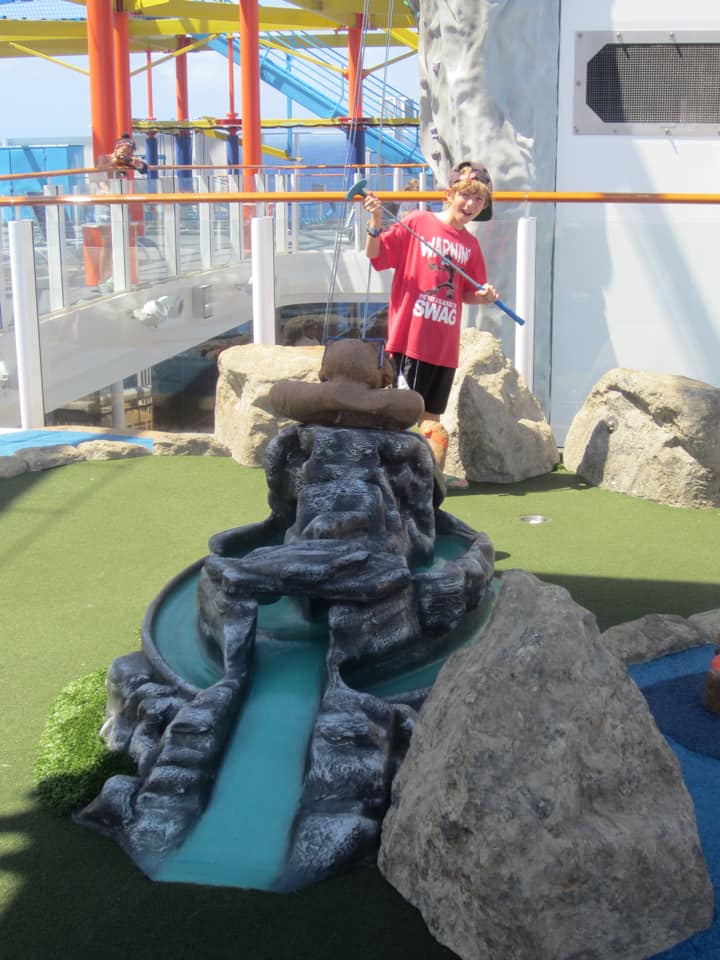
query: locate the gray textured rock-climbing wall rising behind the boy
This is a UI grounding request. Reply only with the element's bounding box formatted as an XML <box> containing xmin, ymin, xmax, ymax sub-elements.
<box><xmin>418</xmin><ymin>0</ymin><xmax>560</xmax><ymax>409</ymax></box>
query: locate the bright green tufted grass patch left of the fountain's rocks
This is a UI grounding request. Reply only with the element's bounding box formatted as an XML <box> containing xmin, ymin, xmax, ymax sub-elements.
<box><xmin>34</xmin><ymin>669</ymin><xmax>135</xmax><ymax>816</ymax></box>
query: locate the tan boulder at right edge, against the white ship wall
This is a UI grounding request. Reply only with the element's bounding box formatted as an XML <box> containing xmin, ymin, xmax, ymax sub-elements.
<box><xmin>563</xmin><ymin>367</ymin><xmax>720</xmax><ymax>508</ymax></box>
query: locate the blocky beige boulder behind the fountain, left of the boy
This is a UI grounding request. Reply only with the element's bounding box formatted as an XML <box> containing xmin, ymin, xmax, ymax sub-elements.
<box><xmin>215</xmin><ymin>343</ymin><xmax>323</xmax><ymax>467</ymax></box>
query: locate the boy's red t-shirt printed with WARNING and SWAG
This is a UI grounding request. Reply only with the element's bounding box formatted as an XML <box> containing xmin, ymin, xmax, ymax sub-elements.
<box><xmin>370</xmin><ymin>210</ymin><xmax>487</xmax><ymax>368</ymax></box>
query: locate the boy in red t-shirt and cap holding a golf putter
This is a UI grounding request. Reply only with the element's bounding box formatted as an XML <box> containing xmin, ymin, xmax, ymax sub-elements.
<box><xmin>363</xmin><ymin>161</ymin><xmax>498</xmax><ymax>486</ymax></box>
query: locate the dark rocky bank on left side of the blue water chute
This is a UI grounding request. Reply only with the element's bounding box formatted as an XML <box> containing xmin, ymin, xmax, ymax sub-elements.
<box><xmin>74</xmin><ymin>648</ymin><xmax>250</xmax><ymax>876</ymax></box>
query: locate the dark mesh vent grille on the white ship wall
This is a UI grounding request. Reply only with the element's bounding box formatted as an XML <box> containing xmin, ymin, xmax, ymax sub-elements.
<box><xmin>586</xmin><ymin>43</ymin><xmax>720</xmax><ymax>124</ymax></box>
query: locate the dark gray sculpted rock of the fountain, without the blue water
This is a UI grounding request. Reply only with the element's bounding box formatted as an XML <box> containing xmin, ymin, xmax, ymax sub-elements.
<box><xmin>76</xmin><ymin>424</ymin><xmax>494</xmax><ymax>890</ymax></box>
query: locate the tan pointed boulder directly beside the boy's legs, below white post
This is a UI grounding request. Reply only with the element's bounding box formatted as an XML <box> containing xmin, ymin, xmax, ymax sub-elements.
<box><xmin>443</xmin><ymin>329</ymin><xmax>560</xmax><ymax>483</ymax></box>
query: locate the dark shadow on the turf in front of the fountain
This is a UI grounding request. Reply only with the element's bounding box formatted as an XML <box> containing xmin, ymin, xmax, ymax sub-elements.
<box><xmin>0</xmin><ymin>798</ymin><xmax>462</xmax><ymax>960</ymax></box>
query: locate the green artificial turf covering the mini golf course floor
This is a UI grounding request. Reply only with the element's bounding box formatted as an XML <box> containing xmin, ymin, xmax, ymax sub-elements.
<box><xmin>0</xmin><ymin>457</ymin><xmax>720</xmax><ymax>960</ymax></box>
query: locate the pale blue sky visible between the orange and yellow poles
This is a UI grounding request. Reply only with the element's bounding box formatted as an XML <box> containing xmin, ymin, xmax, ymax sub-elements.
<box><xmin>0</xmin><ymin>49</ymin><xmax>418</xmax><ymax>142</ymax></box>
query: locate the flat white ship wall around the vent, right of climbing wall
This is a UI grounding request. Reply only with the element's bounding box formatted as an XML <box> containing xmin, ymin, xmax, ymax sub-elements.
<box><xmin>551</xmin><ymin>0</ymin><xmax>720</xmax><ymax>440</ymax></box>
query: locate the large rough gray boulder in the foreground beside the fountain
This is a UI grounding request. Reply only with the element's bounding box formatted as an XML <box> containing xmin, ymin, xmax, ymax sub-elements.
<box><xmin>379</xmin><ymin>571</ymin><xmax>713</xmax><ymax>960</ymax></box>
